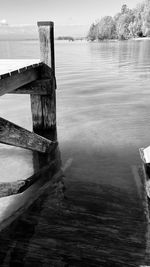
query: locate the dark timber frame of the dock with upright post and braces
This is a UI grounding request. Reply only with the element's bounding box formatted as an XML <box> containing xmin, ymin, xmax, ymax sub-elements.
<box><xmin>0</xmin><ymin>21</ymin><xmax>60</xmax><ymax>197</ymax></box>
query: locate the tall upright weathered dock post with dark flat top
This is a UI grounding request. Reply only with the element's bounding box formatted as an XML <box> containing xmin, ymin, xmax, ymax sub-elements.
<box><xmin>31</xmin><ymin>21</ymin><xmax>57</xmax><ymax>141</ymax></box>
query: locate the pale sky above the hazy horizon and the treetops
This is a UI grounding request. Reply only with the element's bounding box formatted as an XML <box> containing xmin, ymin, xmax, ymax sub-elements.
<box><xmin>0</xmin><ymin>0</ymin><xmax>141</xmax><ymax>25</ymax></box>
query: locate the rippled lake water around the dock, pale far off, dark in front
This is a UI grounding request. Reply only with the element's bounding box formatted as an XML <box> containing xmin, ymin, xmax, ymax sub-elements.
<box><xmin>0</xmin><ymin>40</ymin><xmax>150</xmax><ymax>266</ymax></box>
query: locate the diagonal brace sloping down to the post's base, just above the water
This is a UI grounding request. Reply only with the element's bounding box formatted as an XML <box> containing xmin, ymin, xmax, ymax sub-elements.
<box><xmin>0</xmin><ymin>117</ymin><xmax>56</xmax><ymax>153</ymax></box>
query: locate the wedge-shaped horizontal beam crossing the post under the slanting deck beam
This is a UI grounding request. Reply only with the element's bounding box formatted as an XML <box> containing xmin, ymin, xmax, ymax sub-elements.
<box><xmin>9</xmin><ymin>79</ymin><xmax>55</xmax><ymax>95</ymax></box>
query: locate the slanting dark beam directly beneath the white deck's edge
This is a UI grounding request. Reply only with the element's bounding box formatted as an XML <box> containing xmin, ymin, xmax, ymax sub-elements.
<box><xmin>0</xmin><ymin>67</ymin><xmax>39</xmax><ymax>96</ymax></box>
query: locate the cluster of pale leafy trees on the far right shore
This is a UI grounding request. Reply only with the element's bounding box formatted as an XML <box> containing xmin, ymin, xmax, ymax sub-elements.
<box><xmin>87</xmin><ymin>0</ymin><xmax>150</xmax><ymax>41</ymax></box>
